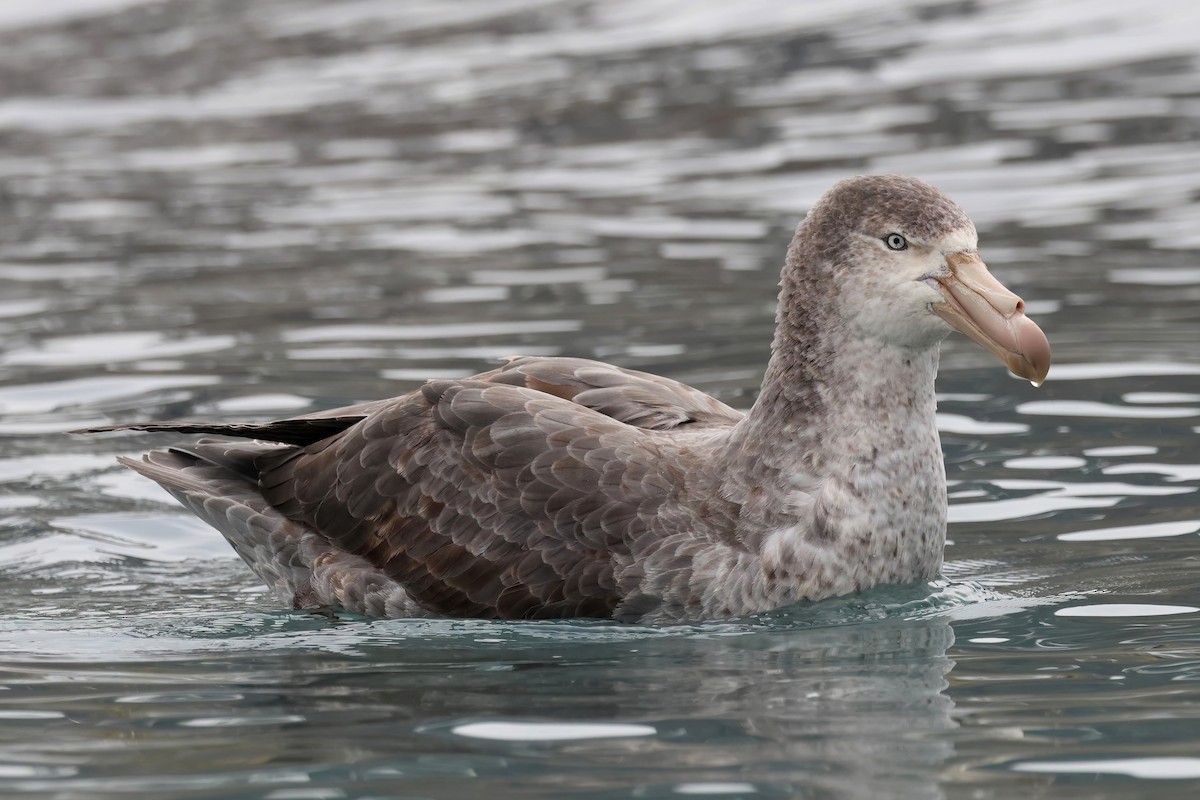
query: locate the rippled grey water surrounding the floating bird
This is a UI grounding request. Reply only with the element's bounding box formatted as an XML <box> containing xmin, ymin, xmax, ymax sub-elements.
<box><xmin>0</xmin><ymin>0</ymin><xmax>1200</xmax><ymax>800</ymax></box>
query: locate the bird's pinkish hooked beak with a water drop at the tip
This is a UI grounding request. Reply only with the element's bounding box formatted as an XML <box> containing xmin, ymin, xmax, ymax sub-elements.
<box><xmin>928</xmin><ymin>252</ymin><xmax>1050</xmax><ymax>386</ymax></box>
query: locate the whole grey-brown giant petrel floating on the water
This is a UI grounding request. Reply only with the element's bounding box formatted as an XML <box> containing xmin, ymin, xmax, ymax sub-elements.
<box><xmin>77</xmin><ymin>176</ymin><xmax>1050</xmax><ymax>622</ymax></box>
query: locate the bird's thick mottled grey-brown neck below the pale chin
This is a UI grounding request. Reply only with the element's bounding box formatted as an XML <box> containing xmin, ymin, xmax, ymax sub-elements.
<box><xmin>722</xmin><ymin>278</ymin><xmax>946</xmax><ymax>581</ymax></box>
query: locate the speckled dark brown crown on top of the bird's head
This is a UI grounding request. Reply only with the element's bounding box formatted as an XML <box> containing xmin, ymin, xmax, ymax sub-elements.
<box><xmin>804</xmin><ymin>175</ymin><xmax>971</xmax><ymax>253</ymax></box>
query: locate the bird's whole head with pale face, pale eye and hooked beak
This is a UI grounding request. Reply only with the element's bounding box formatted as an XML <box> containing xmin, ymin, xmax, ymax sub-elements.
<box><xmin>794</xmin><ymin>175</ymin><xmax>1050</xmax><ymax>385</ymax></box>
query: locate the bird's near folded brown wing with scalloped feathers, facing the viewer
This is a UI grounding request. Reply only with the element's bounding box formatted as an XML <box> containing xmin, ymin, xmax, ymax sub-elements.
<box><xmin>258</xmin><ymin>381</ymin><xmax>673</xmax><ymax>619</ymax></box>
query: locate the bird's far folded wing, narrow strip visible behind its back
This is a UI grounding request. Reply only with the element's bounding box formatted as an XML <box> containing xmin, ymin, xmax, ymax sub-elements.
<box><xmin>475</xmin><ymin>356</ymin><xmax>743</xmax><ymax>431</ymax></box>
